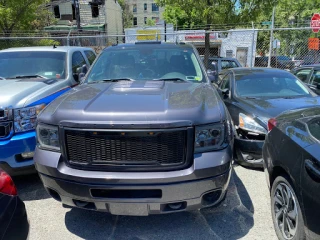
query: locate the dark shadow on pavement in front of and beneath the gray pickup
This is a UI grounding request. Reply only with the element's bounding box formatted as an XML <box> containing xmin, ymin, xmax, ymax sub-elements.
<box><xmin>65</xmin><ymin>171</ymin><xmax>254</xmax><ymax>240</ymax></box>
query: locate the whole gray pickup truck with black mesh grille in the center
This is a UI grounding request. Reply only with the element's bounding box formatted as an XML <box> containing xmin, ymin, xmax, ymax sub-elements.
<box><xmin>35</xmin><ymin>42</ymin><xmax>234</xmax><ymax>215</ymax></box>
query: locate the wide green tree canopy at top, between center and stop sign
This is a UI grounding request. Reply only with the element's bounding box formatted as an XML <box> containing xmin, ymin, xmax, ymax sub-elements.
<box><xmin>156</xmin><ymin>0</ymin><xmax>275</xmax><ymax>29</ymax></box>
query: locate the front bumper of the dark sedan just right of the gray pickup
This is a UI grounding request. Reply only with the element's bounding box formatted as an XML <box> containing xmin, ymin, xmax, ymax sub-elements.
<box><xmin>234</xmin><ymin>138</ymin><xmax>264</xmax><ymax>168</ymax></box>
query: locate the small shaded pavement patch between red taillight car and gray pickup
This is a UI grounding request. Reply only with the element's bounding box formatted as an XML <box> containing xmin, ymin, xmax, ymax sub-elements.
<box><xmin>13</xmin><ymin>174</ymin><xmax>50</xmax><ymax>201</ymax></box>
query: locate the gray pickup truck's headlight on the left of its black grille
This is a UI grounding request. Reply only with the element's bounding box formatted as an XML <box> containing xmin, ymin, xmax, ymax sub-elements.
<box><xmin>36</xmin><ymin>124</ymin><xmax>60</xmax><ymax>151</ymax></box>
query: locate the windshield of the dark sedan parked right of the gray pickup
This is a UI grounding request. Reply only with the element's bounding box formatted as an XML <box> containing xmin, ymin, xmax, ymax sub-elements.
<box><xmin>236</xmin><ymin>73</ymin><xmax>311</xmax><ymax>98</ymax></box>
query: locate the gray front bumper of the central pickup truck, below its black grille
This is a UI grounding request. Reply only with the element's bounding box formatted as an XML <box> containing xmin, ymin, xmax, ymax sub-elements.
<box><xmin>35</xmin><ymin>147</ymin><xmax>232</xmax><ymax>216</ymax></box>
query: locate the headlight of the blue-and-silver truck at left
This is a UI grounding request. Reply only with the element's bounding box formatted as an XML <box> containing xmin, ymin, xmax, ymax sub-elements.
<box><xmin>14</xmin><ymin>104</ymin><xmax>46</xmax><ymax>133</ymax></box>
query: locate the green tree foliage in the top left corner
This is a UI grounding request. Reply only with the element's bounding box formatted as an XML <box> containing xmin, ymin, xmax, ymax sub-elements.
<box><xmin>0</xmin><ymin>0</ymin><xmax>54</xmax><ymax>37</ymax></box>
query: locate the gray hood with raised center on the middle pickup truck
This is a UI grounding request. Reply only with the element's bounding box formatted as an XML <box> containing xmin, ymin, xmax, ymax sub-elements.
<box><xmin>38</xmin><ymin>81</ymin><xmax>224</xmax><ymax>126</ymax></box>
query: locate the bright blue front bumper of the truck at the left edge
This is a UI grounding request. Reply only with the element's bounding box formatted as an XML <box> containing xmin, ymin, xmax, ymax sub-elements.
<box><xmin>0</xmin><ymin>131</ymin><xmax>36</xmax><ymax>175</ymax></box>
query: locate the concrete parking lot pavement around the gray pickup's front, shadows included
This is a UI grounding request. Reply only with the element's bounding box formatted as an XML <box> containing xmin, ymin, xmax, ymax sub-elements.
<box><xmin>15</xmin><ymin>166</ymin><xmax>276</xmax><ymax>240</ymax></box>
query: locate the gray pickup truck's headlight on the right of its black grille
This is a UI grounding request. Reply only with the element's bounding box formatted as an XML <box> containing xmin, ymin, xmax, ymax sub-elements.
<box><xmin>194</xmin><ymin>122</ymin><xmax>232</xmax><ymax>153</ymax></box>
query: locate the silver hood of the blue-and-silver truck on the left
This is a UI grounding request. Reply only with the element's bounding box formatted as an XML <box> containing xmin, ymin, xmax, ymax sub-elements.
<box><xmin>0</xmin><ymin>79</ymin><xmax>56</xmax><ymax>108</ymax></box>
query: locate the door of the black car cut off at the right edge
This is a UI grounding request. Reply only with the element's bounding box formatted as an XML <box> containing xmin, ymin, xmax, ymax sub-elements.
<box><xmin>301</xmin><ymin>117</ymin><xmax>320</xmax><ymax>239</ymax></box>
